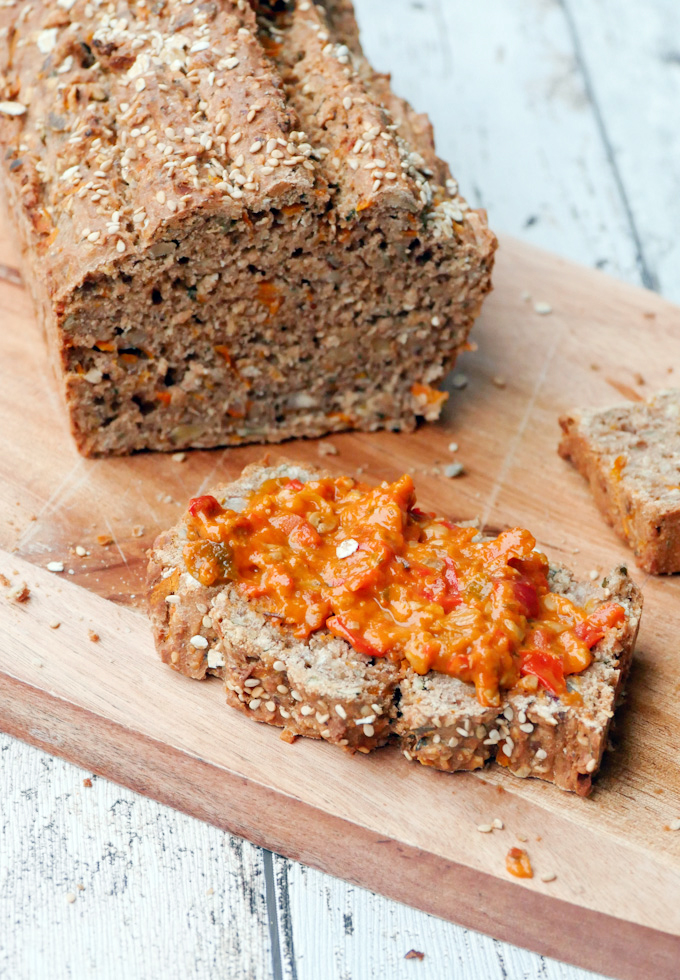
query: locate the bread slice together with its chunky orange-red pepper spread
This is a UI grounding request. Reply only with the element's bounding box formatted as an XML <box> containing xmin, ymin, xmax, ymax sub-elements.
<box><xmin>149</xmin><ymin>462</ymin><xmax>642</xmax><ymax>795</ymax></box>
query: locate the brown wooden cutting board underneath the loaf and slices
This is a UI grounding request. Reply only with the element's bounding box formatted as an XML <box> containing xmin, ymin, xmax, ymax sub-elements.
<box><xmin>0</xmin><ymin>209</ymin><xmax>680</xmax><ymax>980</ymax></box>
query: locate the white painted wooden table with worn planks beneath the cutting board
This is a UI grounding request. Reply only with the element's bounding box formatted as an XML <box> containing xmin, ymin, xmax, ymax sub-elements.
<box><xmin>0</xmin><ymin>0</ymin><xmax>680</xmax><ymax>980</ymax></box>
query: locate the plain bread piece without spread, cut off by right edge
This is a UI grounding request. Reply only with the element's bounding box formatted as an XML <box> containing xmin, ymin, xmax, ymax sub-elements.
<box><xmin>559</xmin><ymin>389</ymin><xmax>680</xmax><ymax>575</ymax></box>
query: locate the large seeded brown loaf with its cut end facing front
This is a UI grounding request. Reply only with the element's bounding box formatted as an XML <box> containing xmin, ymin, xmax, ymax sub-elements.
<box><xmin>0</xmin><ymin>0</ymin><xmax>496</xmax><ymax>454</ymax></box>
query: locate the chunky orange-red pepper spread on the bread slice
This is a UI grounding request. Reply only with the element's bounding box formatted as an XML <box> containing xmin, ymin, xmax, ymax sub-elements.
<box><xmin>184</xmin><ymin>476</ymin><xmax>624</xmax><ymax>705</ymax></box>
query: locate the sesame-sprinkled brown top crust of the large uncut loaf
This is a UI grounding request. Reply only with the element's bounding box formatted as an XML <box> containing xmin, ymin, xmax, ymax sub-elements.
<box><xmin>0</xmin><ymin>0</ymin><xmax>480</xmax><ymax>299</ymax></box>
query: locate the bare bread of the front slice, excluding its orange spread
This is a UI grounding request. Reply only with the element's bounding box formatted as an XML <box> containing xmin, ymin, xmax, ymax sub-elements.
<box><xmin>148</xmin><ymin>462</ymin><xmax>642</xmax><ymax>795</ymax></box>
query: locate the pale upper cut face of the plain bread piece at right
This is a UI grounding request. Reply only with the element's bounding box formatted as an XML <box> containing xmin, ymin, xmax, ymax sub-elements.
<box><xmin>561</xmin><ymin>389</ymin><xmax>680</xmax><ymax>510</ymax></box>
